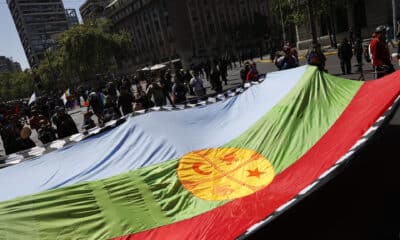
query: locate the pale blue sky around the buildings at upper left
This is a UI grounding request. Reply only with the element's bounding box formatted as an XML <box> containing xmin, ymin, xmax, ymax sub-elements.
<box><xmin>0</xmin><ymin>0</ymin><xmax>85</xmax><ymax>69</ymax></box>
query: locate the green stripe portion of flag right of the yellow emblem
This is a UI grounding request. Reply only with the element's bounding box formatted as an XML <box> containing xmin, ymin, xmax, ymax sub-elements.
<box><xmin>227</xmin><ymin>67</ymin><xmax>362</xmax><ymax>173</ymax></box>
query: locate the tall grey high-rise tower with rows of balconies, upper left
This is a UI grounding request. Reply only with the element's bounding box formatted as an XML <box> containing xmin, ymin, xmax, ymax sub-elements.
<box><xmin>7</xmin><ymin>0</ymin><xmax>68</xmax><ymax>67</ymax></box>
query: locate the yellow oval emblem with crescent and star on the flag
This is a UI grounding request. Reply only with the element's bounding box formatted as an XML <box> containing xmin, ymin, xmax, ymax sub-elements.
<box><xmin>178</xmin><ymin>148</ymin><xmax>275</xmax><ymax>201</ymax></box>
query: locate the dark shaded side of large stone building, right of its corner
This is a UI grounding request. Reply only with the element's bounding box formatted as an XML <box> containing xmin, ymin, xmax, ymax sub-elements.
<box><xmin>187</xmin><ymin>0</ymin><xmax>272</xmax><ymax>57</ymax></box>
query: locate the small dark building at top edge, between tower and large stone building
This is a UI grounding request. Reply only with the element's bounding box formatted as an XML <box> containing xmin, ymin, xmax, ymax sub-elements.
<box><xmin>79</xmin><ymin>0</ymin><xmax>110</xmax><ymax>23</ymax></box>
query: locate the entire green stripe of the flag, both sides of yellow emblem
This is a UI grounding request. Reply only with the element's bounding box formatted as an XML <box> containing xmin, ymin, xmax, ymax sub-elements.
<box><xmin>0</xmin><ymin>67</ymin><xmax>362</xmax><ymax>240</ymax></box>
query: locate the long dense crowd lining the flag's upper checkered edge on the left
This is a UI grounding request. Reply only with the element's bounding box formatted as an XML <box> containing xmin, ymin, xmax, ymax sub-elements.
<box><xmin>0</xmin><ymin>59</ymin><xmax>258</xmax><ymax>155</ymax></box>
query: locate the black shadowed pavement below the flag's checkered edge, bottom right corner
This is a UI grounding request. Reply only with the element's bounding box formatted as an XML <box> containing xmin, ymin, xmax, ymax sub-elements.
<box><xmin>248</xmin><ymin>125</ymin><xmax>400</xmax><ymax>240</ymax></box>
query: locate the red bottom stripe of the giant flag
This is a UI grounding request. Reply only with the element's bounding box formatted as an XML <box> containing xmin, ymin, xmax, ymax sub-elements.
<box><xmin>115</xmin><ymin>72</ymin><xmax>400</xmax><ymax>240</ymax></box>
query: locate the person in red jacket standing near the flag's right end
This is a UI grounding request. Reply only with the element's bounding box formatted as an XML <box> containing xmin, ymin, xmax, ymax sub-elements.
<box><xmin>369</xmin><ymin>26</ymin><xmax>394</xmax><ymax>78</ymax></box>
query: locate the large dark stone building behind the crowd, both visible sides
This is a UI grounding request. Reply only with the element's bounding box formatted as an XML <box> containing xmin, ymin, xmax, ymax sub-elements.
<box><xmin>105</xmin><ymin>0</ymin><xmax>269</xmax><ymax>67</ymax></box>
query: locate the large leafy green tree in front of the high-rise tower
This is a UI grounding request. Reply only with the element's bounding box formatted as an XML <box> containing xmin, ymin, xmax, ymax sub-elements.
<box><xmin>38</xmin><ymin>20</ymin><xmax>132</xmax><ymax>90</ymax></box>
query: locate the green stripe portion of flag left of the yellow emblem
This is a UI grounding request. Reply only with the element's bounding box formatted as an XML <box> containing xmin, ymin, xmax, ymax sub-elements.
<box><xmin>0</xmin><ymin>160</ymin><xmax>224</xmax><ymax>240</ymax></box>
